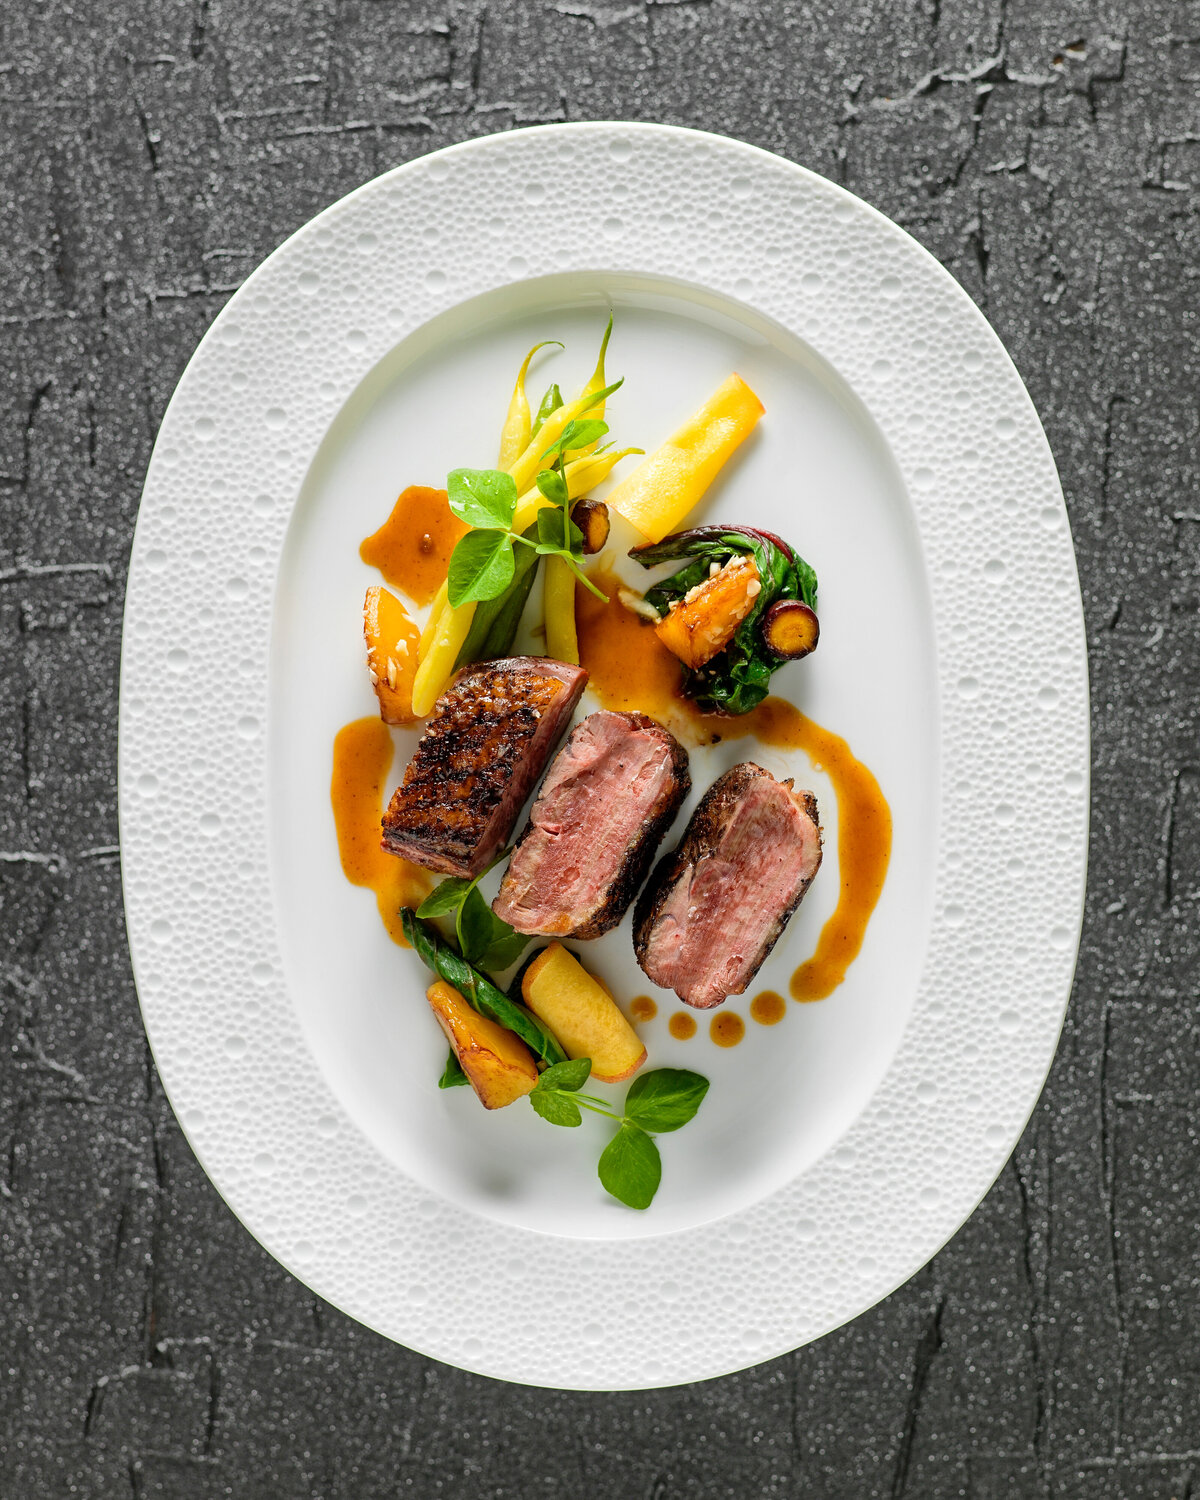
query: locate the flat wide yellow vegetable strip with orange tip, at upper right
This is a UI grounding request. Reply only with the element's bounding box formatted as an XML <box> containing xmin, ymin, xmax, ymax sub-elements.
<box><xmin>608</xmin><ymin>375</ymin><xmax>764</xmax><ymax>542</ymax></box>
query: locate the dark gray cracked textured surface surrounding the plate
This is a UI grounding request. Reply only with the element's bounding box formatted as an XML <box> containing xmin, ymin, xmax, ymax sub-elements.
<box><xmin>0</xmin><ymin>0</ymin><xmax>1200</xmax><ymax>1500</ymax></box>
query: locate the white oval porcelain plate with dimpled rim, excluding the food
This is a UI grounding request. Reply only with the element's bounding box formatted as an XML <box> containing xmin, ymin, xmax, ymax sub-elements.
<box><xmin>120</xmin><ymin>125</ymin><xmax>1088</xmax><ymax>1389</ymax></box>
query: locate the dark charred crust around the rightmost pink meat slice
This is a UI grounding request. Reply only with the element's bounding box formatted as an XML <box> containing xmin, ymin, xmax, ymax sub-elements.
<box><xmin>633</xmin><ymin>761</ymin><xmax>821</xmax><ymax>1010</ymax></box>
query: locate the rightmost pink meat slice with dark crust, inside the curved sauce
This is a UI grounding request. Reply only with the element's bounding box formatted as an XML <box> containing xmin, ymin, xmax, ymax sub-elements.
<box><xmin>633</xmin><ymin>761</ymin><xmax>821</xmax><ymax>1010</ymax></box>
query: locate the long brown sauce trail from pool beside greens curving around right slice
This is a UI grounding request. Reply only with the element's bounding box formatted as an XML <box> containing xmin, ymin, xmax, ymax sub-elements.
<box><xmin>576</xmin><ymin>569</ymin><xmax>891</xmax><ymax>1008</ymax></box>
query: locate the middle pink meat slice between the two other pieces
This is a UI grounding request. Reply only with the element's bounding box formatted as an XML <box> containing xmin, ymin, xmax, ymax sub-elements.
<box><xmin>492</xmin><ymin>711</ymin><xmax>692</xmax><ymax>938</ymax></box>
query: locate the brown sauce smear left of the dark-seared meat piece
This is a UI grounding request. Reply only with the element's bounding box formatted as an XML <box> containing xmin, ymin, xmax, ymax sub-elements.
<box><xmin>330</xmin><ymin>719</ymin><xmax>434</xmax><ymax>948</ymax></box>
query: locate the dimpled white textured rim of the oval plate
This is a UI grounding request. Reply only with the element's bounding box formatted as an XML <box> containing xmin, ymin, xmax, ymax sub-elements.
<box><xmin>120</xmin><ymin>125</ymin><xmax>1088</xmax><ymax>1389</ymax></box>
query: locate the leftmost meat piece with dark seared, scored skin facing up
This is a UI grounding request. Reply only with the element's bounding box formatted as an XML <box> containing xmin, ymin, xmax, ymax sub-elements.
<box><xmin>383</xmin><ymin>657</ymin><xmax>588</xmax><ymax>876</ymax></box>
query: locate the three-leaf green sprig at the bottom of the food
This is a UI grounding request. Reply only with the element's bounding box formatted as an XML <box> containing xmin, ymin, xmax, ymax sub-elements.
<box><xmin>527</xmin><ymin>1058</ymin><xmax>708</xmax><ymax>1209</ymax></box>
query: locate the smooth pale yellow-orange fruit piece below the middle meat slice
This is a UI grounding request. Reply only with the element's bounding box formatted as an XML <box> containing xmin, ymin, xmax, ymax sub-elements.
<box><xmin>521</xmin><ymin>942</ymin><xmax>647</xmax><ymax>1083</ymax></box>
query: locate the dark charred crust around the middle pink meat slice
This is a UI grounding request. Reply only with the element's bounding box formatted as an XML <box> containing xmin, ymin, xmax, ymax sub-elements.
<box><xmin>492</xmin><ymin>711</ymin><xmax>692</xmax><ymax>939</ymax></box>
